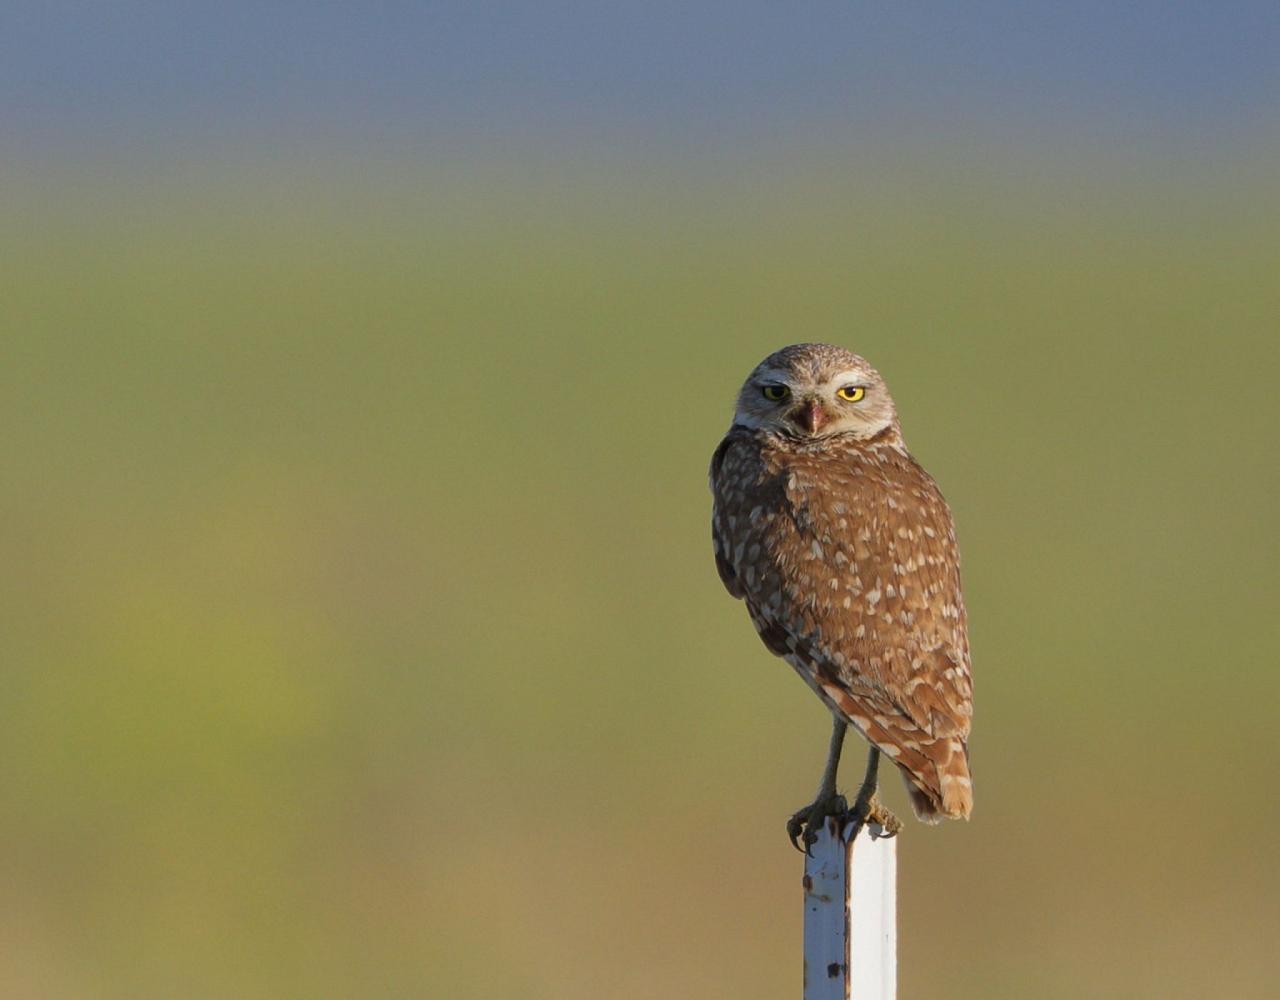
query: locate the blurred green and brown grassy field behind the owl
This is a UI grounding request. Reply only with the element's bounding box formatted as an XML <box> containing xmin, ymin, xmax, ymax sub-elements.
<box><xmin>0</xmin><ymin>156</ymin><xmax>1280</xmax><ymax>1000</ymax></box>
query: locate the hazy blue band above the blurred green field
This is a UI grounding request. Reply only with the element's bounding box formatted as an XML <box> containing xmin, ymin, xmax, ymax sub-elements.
<box><xmin>0</xmin><ymin>0</ymin><xmax>1280</xmax><ymax>158</ymax></box>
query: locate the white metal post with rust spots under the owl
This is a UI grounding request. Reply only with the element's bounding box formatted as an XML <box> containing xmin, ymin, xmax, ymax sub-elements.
<box><xmin>804</xmin><ymin>817</ymin><xmax>897</xmax><ymax>1000</ymax></box>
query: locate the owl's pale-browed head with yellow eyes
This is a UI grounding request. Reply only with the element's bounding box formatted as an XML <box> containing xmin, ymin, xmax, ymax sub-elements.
<box><xmin>733</xmin><ymin>343</ymin><xmax>899</xmax><ymax>440</ymax></box>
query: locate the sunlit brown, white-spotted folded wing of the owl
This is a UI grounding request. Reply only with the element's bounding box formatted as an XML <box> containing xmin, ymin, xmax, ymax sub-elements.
<box><xmin>780</xmin><ymin>449</ymin><xmax>973</xmax><ymax>739</ymax></box>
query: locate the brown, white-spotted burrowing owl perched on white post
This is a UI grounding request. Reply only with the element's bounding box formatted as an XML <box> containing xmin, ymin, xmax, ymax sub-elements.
<box><xmin>710</xmin><ymin>343</ymin><xmax>973</xmax><ymax>845</ymax></box>
